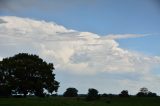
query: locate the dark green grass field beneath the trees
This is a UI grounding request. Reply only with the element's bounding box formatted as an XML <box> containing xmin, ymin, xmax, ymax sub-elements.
<box><xmin>0</xmin><ymin>97</ymin><xmax>160</xmax><ymax>106</ymax></box>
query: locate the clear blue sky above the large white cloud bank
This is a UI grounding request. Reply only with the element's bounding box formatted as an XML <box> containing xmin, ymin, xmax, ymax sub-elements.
<box><xmin>0</xmin><ymin>0</ymin><xmax>160</xmax><ymax>55</ymax></box>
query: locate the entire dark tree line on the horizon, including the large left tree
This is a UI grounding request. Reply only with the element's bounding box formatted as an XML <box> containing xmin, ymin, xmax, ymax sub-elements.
<box><xmin>0</xmin><ymin>53</ymin><xmax>157</xmax><ymax>100</ymax></box>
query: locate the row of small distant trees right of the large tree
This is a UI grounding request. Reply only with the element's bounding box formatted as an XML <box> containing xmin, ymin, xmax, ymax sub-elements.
<box><xmin>63</xmin><ymin>87</ymin><xmax>158</xmax><ymax>100</ymax></box>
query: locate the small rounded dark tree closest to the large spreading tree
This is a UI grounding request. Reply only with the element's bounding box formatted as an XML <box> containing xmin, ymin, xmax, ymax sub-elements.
<box><xmin>63</xmin><ymin>88</ymin><xmax>78</xmax><ymax>97</ymax></box>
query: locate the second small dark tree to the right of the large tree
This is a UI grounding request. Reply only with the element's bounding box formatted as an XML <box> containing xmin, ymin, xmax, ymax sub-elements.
<box><xmin>87</xmin><ymin>88</ymin><xmax>99</xmax><ymax>101</ymax></box>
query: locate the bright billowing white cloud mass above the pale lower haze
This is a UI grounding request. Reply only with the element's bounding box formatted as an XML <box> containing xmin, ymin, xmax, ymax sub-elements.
<box><xmin>0</xmin><ymin>16</ymin><xmax>160</xmax><ymax>74</ymax></box>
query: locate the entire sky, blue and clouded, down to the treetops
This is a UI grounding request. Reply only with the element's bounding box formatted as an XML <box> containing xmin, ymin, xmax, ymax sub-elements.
<box><xmin>0</xmin><ymin>0</ymin><xmax>160</xmax><ymax>94</ymax></box>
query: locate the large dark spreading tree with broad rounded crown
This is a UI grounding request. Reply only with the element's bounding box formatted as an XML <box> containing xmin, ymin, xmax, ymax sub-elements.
<box><xmin>0</xmin><ymin>53</ymin><xmax>59</xmax><ymax>96</ymax></box>
